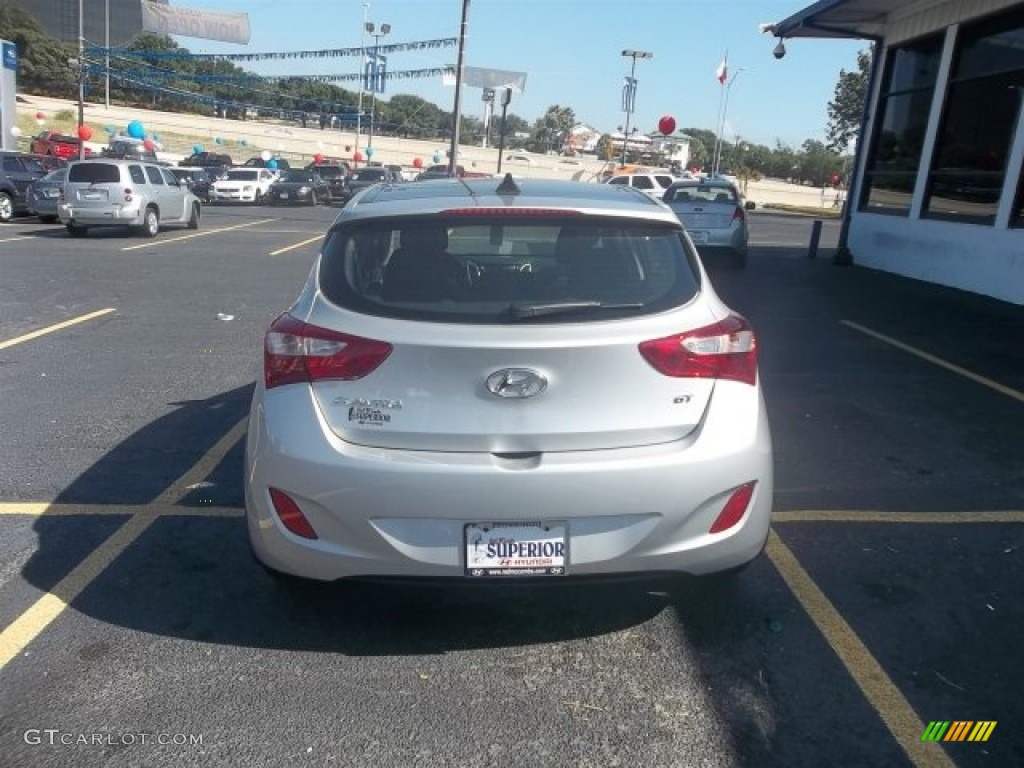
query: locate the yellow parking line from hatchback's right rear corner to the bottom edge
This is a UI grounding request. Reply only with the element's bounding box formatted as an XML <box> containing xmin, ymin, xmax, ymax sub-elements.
<box><xmin>766</xmin><ymin>531</ymin><xmax>953</xmax><ymax>768</ymax></box>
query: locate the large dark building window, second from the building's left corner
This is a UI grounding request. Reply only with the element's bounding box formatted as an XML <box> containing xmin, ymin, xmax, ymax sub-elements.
<box><xmin>923</xmin><ymin>9</ymin><xmax>1024</xmax><ymax>224</ymax></box>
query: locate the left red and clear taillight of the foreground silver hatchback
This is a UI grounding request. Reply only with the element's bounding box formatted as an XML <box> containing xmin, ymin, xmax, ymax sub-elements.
<box><xmin>263</xmin><ymin>314</ymin><xmax>391</xmax><ymax>389</ymax></box>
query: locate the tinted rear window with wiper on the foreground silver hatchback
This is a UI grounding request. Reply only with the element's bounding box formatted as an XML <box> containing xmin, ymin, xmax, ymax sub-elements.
<box><xmin>319</xmin><ymin>215</ymin><xmax>698</xmax><ymax>324</ymax></box>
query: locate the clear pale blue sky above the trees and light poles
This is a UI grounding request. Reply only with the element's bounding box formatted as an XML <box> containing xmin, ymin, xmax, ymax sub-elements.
<box><xmin>163</xmin><ymin>0</ymin><xmax>867</xmax><ymax>148</ymax></box>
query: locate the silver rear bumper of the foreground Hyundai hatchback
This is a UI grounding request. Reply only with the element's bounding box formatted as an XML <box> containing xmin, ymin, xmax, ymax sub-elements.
<box><xmin>245</xmin><ymin>382</ymin><xmax>773</xmax><ymax>581</ymax></box>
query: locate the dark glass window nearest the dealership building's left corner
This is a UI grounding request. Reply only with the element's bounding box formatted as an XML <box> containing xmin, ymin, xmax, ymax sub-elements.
<box><xmin>860</xmin><ymin>35</ymin><xmax>943</xmax><ymax>216</ymax></box>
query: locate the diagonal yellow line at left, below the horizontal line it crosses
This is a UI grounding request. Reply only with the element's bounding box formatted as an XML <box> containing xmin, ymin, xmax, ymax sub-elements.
<box><xmin>0</xmin><ymin>515</ymin><xmax>157</xmax><ymax>670</ymax></box>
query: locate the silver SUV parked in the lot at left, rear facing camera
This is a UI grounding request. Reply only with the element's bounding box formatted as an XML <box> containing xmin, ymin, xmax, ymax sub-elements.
<box><xmin>57</xmin><ymin>159</ymin><xmax>202</xmax><ymax>238</ymax></box>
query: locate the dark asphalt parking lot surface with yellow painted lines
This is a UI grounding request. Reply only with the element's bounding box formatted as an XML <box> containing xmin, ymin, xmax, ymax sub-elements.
<box><xmin>0</xmin><ymin>206</ymin><xmax>1024</xmax><ymax>768</ymax></box>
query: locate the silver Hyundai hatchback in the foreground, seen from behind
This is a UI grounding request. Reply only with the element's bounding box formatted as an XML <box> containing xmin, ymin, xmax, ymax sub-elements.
<box><xmin>245</xmin><ymin>175</ymin><xmax>772</xmax><ymax>581</ymax></box>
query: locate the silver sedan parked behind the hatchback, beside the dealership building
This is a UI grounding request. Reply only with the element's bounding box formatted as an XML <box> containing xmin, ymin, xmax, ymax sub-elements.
<box><xmin>662</xmin><ymin>178</ymin><xmax>750</xmax><ymax>268</ymax></box>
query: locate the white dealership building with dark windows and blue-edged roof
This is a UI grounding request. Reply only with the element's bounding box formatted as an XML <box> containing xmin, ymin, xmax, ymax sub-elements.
<box><xmin>766</xmin><ymin>0</ymin><xmax>1024</xmax><ymax>304</ymax></box>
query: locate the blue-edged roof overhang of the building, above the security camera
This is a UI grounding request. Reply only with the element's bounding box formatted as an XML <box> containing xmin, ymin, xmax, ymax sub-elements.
<box><xmin>761</xmin><ymin>0</ymin><xmax>925</xmax><ymax>38</ymax></box>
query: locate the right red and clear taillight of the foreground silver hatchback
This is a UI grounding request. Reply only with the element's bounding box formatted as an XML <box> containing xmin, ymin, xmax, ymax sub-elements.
<box><xmin>640</xmin><ymin>314</ymin><xmax>758</xmax><ymax>386</ymax></box>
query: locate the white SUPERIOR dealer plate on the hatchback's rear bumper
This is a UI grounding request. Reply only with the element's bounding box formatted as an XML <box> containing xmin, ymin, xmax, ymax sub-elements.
<box><xmin>464</xmin><ymin>522</ymin><xmax>568</xmax><ymax>577</ymax></box>
